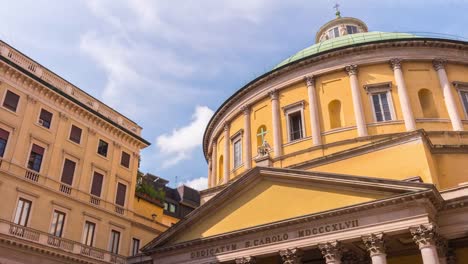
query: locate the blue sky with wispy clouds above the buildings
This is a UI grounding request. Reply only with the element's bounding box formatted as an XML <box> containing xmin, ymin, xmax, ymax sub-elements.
<box><xmin>0</xmin><ymin>0</ymin><xmax>468</xmax><ymax>188</ymax></box>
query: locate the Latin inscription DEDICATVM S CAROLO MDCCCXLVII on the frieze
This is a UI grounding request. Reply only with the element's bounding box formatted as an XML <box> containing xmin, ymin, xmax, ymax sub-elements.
<box><xmin>190</xmin><ymin>219</ymin><xmax>359</xmax><ymax>259</ymax></box>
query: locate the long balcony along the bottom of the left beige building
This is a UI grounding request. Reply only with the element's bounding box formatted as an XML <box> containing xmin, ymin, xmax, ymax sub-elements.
<box><xmin>0</xmin><ymin>219</ymin><xmax>127</xmax><ymax>264</ymax></box>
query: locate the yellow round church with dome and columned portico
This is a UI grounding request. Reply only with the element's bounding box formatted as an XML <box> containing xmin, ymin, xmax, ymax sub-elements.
<box><xmin>140</xmin><ymin>13</ymin><xmax>468</xmax><ymax>264</ymax></box>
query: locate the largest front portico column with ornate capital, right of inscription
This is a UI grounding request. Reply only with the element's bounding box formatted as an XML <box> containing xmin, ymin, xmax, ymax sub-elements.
<box><xmin>410</xmin><ymin>223</ymin><xmax>440</xmax><ymax>264</ymax></box>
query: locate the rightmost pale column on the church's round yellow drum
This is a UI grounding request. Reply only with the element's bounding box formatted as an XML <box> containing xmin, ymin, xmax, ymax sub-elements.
<box><xmin>432</xmin><ymin>59</ymin><xmax>463</xmax><ymax>131</ymax></box>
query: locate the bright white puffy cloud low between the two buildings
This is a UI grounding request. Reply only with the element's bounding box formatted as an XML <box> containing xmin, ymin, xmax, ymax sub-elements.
<box><xmin>156</xmin><ymin>106</ymin><xmax>213</xmax><ymax>168</ymax></box>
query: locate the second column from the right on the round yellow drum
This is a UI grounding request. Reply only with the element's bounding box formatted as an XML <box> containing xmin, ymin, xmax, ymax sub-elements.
<box><xmin>390</xmin><ymin>59</ymin><xmax>416</xmax><ymax>131</ymax></box>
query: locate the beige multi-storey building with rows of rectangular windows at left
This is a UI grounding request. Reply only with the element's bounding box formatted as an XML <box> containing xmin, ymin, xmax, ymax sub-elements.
<box><xmin>0</xmin><ymin>42</ymin><xmax>168</xmax><ymax>264</ymax></box>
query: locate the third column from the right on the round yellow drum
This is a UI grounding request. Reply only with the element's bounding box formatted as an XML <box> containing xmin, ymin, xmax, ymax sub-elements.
<box><xmin>345</xmin><ymin>65</ymin><xmax>367</xmax><ymax>137</ymax></box>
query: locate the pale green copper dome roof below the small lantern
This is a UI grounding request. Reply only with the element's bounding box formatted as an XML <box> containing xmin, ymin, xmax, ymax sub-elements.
<box><xmin>273</xmin><ymin>31</ymin><xmax>419</xmax><ymax>69</ymax></box>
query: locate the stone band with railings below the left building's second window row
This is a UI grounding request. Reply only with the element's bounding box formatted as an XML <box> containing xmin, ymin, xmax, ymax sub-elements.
<box><xmin>0</xmin><ymin>158</ymin><xmax>128</xmax><ymax>215</ymax></box>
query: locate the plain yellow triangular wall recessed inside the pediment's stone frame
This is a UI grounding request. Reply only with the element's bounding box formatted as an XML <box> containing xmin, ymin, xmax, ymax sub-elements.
<box><xmin>176</xmin><ymin>179</ymin><xmax>383</xmax><ymax>242</ymax></box>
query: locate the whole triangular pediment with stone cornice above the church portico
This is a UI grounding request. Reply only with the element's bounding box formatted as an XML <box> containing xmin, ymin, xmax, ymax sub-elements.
<box><xmin>145</xmin><ymin>168</ymin><xmax>436</xmax><ymax>252</ymax></box>
